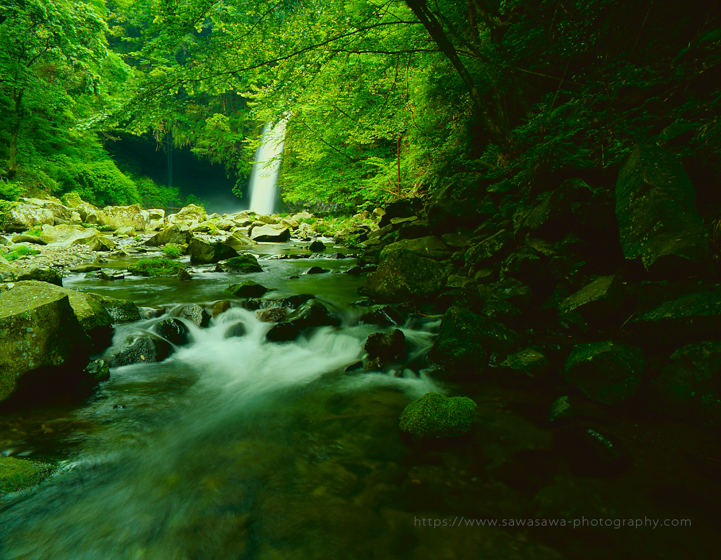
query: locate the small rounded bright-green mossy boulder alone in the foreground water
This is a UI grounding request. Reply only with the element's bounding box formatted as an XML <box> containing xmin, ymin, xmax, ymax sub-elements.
<box><xmin>399</xmin><ymin>393</ymin><xmax>477</xmax><ymax>441</ymax></box>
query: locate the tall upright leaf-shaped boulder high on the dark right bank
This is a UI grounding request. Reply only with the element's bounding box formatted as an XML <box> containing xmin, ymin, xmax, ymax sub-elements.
<box><xmin>616</xmin><ymin>146</ymin><xmax>708</xmax><ymax>272</ymax></box>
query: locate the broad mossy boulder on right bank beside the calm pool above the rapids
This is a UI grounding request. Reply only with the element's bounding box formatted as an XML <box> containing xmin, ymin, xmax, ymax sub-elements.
<box><xmin>361</xmin><ymin>238</ymin><xmax>446</xmax><ymax>301</ymax></box>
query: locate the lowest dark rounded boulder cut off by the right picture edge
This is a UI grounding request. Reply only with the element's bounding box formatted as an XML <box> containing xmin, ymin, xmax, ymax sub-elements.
<box><xmin>655</xmin><ymin>340</ymin><xmax>721</xmax><ymax>426</ymax></box>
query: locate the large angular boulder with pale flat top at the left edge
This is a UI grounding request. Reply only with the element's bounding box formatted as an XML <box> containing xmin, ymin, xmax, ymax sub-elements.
<box><xmin>0</xmin><ymin>282</ymin><xmax>89</xmax><ymax>401</ymax></box>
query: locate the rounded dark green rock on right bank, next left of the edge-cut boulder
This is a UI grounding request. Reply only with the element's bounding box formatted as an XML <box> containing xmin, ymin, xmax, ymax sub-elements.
<box><xmin>565</xmin><ymin>341</ymin><xmax>644</xmax><ymax>405</ymax></box>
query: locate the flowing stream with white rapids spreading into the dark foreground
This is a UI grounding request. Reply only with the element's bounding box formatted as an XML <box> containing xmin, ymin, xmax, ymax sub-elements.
<box><xmin>0</xmin><ymin>238</ymin><xmax>718</xmax><ymax>560</ymax></box>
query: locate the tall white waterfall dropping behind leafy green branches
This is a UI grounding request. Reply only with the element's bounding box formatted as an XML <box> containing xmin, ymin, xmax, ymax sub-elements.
<box><xmin>248</xmin><ymin>119</ymin><xmax>286</xmax><ymax>214</ymax></box>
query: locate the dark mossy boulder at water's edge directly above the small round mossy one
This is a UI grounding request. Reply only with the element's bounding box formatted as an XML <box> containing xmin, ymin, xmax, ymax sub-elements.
<box><xmin>430</xmin><ymin>306</ymin><xmax>518</xmax><ymax>377</ymax></box>
